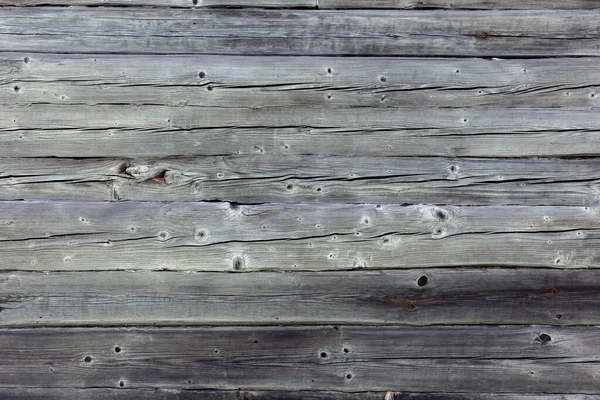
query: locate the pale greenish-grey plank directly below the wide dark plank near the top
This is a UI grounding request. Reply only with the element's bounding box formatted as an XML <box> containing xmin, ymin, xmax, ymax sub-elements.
<box><xmin>0</xmin><ymin>54</ymin><xmax>600</xmax><ymax>112</ymax></box>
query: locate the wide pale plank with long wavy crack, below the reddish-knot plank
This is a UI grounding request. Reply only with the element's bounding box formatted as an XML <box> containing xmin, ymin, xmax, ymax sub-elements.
<box><xmin>0</xmin><ymin>202</ymin><xmax>600</xmax><ymax>271</ymax></box>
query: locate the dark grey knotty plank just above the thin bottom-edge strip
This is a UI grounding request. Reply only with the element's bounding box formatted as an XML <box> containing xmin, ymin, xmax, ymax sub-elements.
<box><xmin>0</xmin><ymin>327</ymin><xmax>600</xmax><ymax>394</ymax></box>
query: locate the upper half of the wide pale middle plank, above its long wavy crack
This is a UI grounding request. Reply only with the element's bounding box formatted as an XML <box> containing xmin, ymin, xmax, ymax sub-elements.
<box><xmin>0</xmin><ymin>201</ymin><xmax>600</xmax><ymax>246</ymax></box>
